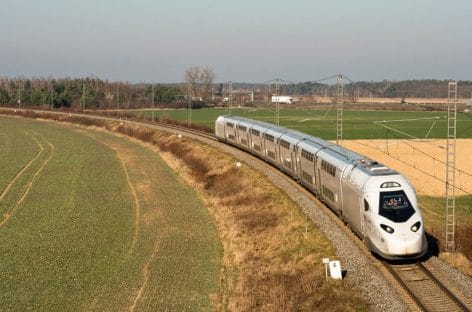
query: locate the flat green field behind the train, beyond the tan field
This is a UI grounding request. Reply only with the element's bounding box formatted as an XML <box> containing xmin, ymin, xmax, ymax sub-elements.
<box><xmin>134</xmin><ymin>108</ymin><xmax>472</xmax><ymax>140</ymax></box>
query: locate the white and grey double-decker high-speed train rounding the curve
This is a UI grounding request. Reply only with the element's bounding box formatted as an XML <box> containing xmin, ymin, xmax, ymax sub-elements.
<box><xmin>215</xmin><ymin>116</ymin><xmax>428</xmax><ymax>260</ymax></box>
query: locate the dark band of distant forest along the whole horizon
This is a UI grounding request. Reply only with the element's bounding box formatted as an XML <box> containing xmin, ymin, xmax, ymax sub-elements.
<box><xmin>0</xmin><ymin>77</ymin><xmax>472</xmax><ymax>109</ymax></box>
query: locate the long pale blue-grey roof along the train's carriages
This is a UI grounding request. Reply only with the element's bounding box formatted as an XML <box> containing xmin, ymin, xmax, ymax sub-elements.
<box><xmin>220</xmin><ymin>115</ymin><xmax>398</xmax><ymax>176</ymax></box>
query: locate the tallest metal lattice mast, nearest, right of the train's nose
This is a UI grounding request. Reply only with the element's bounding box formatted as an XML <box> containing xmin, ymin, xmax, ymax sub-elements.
<box><xmin>445</xmin><ymin>81</ymin><xmax>457</xmax><ymax>251</ymax></box>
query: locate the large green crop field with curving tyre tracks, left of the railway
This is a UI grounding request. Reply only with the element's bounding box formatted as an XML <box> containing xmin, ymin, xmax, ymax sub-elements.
<box><xmin>0</xmin><ymin>117</ymin><xmax>222</xmax><ymax>311</ymax></box>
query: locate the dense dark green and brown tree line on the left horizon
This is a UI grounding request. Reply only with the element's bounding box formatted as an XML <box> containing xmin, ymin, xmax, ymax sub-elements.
<box><xmin>0</xmin><ymin>77</ymin><xmax>185</xmax><ymax>109</ymax></box>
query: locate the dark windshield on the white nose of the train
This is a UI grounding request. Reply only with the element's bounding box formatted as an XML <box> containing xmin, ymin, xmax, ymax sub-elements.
<box><xmin>379</xmin><ymin>191</ymin><xmax>415</xmax><ymax>222</ymax></box>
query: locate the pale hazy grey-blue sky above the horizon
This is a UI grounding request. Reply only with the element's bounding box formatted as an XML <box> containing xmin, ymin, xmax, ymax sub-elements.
<box><xmin>0</xmin><ymin>0</ymin><xmax>472</xmax><ymax>82</ymax></box>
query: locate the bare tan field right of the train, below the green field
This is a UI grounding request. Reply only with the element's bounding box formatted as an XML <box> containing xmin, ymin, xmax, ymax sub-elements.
<box><xmin>343</xmin><ymin>139</ymin><xmax>472</xmax><ymax>196</ymax></box>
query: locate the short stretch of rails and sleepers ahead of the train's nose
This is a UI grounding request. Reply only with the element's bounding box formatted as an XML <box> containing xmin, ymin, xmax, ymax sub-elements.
<box><xmin>382</xmin><ymin>262</ymin><xmax>471</xmax><ymax>312</ymax></box>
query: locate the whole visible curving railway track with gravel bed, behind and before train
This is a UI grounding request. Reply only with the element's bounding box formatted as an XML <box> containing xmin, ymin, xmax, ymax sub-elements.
<box><xmin>2</xmin><ymin>107</ymin><xmax>472</xmax><ymax>312</ymax></box>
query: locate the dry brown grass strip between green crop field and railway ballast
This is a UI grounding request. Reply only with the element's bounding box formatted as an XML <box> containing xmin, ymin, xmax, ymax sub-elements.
<box><xmin>0</xmin><ymin>109</ymin><xmax>367</xmax><ymax>311</ymax></box>
